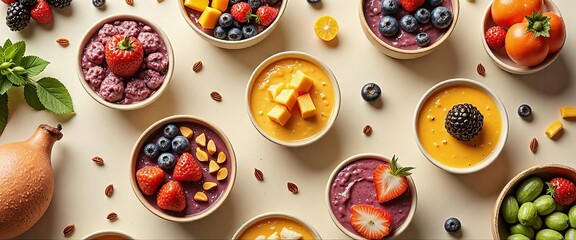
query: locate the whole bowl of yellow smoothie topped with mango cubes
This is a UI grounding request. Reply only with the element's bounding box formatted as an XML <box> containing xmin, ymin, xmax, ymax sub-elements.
<box><xmin>246</xmin><ymin>51</ymin><xmax>340</xmax><ymax>147</ymax></box>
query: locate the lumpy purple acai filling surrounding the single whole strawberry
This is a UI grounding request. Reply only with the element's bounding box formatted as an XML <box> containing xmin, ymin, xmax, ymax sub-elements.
<box><xmin>81</xmin><ymin>20</ymin><xmax>170</xmax><ymax>104</ymax></box>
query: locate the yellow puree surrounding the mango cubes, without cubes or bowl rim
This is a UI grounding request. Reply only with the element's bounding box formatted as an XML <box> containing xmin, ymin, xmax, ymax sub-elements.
<box><xmin>250</xmin><ymin>58</ymin><xmax>335</xmax><ymax>141</ymax></box>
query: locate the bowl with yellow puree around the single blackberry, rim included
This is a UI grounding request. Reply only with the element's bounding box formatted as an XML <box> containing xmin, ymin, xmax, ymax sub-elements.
<box><xmin>414</xmin><ymin>78</ymin><xmax>509</xmax><ymax>174</ymax></box>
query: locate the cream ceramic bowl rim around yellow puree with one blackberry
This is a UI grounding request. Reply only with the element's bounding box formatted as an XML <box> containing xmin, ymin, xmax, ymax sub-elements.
<box><xmin>414</xmin><ymin>78</ymin><xmax>509</xmax><ymax>174</ymax></box>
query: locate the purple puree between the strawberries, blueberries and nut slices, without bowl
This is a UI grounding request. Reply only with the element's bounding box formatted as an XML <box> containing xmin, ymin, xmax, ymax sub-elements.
<box><xmin>136</xmin><ymin>122</ymin><xmax>232</xmax><ymax>217</ymax></box>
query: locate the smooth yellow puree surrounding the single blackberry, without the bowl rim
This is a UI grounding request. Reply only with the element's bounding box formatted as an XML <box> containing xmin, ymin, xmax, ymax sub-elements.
<box><xmin>418</xmin><ymin>86</ymin><xmax>502</xmax><ymax>168</ymax></box>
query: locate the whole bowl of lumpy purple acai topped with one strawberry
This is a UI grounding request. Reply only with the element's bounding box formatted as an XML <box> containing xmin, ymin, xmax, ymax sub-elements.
<box><xmin>77</xmin><ymin>14</ymin><xmax>174</xmax><ymax>110</ymax></box>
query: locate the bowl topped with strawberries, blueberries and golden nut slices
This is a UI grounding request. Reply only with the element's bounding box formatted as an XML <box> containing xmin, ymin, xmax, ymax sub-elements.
<box><xmin>130</xmin><ymin>115</ymin><xmax>236</xmax><ymax>222</ymax></box>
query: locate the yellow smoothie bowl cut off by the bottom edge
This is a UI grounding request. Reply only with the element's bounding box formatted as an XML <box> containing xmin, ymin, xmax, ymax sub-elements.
<box><xmin>232</xmin><ymin>212</ymin><xmax>322</xmax><ymax>240</ymax></box>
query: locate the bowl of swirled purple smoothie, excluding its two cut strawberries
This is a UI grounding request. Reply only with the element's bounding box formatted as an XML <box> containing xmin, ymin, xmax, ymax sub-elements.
<box><xmin>326</xmin><ymin>153</ymin><xmax>417</xmax><ymax>239</ymax></box>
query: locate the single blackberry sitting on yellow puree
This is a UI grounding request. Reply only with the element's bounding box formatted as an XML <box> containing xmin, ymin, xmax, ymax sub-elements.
<box><xmin>444</xmin><ymin>103</ymin><xmax>484</xmax><ymax>142</ymax></box>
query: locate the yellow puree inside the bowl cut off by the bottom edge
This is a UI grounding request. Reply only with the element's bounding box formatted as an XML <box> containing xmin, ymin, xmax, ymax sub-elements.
<box><xmin>239</xmin><ymin>217</ymin><xmax>314</xmax><ymax>240</ymax></box>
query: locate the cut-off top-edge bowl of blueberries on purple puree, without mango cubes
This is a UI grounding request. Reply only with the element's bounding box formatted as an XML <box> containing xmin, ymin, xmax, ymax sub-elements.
<box><xmin>358</xmin><ymin>0</ymin><xmax>460</xmax><ymax>59</ymax></box>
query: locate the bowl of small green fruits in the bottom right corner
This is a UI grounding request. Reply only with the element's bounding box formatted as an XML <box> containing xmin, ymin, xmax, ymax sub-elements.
<box><xmin>491</xmin><ymin>164</ymin><xmax>576</xmax><ymax>239</ymax></box>
